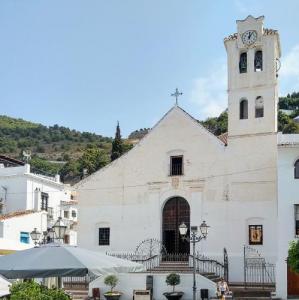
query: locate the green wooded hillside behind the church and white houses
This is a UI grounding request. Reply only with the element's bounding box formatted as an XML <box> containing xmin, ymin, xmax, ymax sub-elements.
<box><xmin>0</xmin><ymin>93</ymin><xmax>299</xmax><ymax>183</ymax></box>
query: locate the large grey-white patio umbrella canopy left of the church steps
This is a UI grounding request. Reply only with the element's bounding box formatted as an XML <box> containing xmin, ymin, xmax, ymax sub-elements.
<box><xmin>0</xmin><ymin>244</ymin><xmax>144</xmax><ymax>279</ymax></box>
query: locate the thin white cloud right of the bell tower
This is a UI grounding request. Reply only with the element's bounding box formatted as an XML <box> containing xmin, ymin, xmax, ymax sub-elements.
<box><xmin>279</xmin><ymin>44</ymin><xmax>299</xmax><ymax>95</ymax></box>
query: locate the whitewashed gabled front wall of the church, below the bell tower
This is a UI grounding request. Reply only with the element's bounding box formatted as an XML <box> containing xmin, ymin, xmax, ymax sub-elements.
<box><xmin>78</xmin><ymin>107</ymin><xmax>277</xmax><ymax>281</ymax></box>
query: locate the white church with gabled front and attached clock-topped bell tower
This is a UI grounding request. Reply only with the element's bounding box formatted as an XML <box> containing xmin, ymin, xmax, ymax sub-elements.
<box><xmin>76</xmin><ymin>16</ymin><xmax>280</xmax><ymax>282</ymax></box>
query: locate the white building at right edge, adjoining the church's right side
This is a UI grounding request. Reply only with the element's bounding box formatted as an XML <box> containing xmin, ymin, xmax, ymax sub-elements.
<box><xmin>277</xmin><ymin>134</ymin><xmax>299</xmax><ymax>299</ymax></box>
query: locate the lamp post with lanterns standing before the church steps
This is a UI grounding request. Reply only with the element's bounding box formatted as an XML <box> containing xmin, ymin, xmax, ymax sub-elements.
<box><xmin>179</xmin><ymin>221</ymin><xmax>210</xmax><ymax>300</ymax></box>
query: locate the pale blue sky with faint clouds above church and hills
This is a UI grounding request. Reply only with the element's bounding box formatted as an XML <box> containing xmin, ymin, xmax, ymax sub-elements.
<box><xmin>0</xmin><ymin>0</ymin><xmax>299</xmax><ymax>136</ymax></box>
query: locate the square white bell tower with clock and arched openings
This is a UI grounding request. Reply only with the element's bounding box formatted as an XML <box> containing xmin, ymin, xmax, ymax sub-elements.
<box><xmin>224</xmin><ymin>16</ymin><xmax>281</xmax><ymax>137</ymax></box>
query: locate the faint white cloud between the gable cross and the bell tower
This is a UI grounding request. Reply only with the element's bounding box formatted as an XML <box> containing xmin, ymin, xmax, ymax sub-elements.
<box><xmin>191</xmin><ymin>63</ymin><xmax>227</xmax><ymax>119</ymax></box>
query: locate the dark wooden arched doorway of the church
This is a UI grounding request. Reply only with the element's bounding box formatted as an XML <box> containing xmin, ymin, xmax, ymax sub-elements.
<box><xmin>162</xmin><ymin>197</ymin><xmax>190</xmax><ymax>254</ymax></box>
